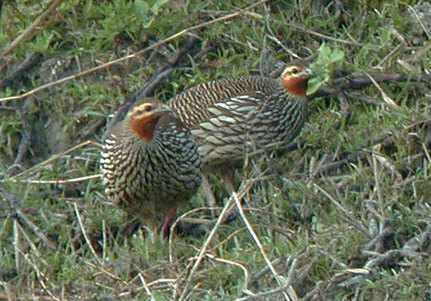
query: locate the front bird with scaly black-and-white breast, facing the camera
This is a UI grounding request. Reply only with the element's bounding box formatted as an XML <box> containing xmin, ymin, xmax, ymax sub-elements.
<box><xmin>100</xmin><ymin>98</ymin><xmax>202</xmax><ymax>237</ymax></box>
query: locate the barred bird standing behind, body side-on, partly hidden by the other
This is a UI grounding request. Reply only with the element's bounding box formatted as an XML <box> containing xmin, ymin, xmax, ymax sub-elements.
<box><xmin>168</xmin><ymin>61</ymin><xmax>313</xmax><ymax>204</ymax></box>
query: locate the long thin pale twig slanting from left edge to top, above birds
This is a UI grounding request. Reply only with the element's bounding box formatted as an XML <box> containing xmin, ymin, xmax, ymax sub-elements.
<box><xmin>0</xmin><ymin>0</ymin><xmax>270</xmax><ymax>103</ymax></box>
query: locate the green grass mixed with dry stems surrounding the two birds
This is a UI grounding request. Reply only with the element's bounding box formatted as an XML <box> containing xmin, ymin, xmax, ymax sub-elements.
<box><xmin>0</xmin><ymin>0</ymin><xmax>431</xmax><ymax>300</ymax></box>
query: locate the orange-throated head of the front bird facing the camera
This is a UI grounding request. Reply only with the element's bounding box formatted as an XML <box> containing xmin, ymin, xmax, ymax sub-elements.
<box><xmin>127</xmin><ymin>101</ymin><xmax>173</xmax><ymax>142</ymax></box>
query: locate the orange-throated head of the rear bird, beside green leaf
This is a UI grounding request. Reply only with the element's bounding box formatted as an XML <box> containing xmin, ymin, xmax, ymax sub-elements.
<box><xmin>280</xmin><ymin>64</ymin><xmax>313</xmax><ymax>97</ymax></box>
